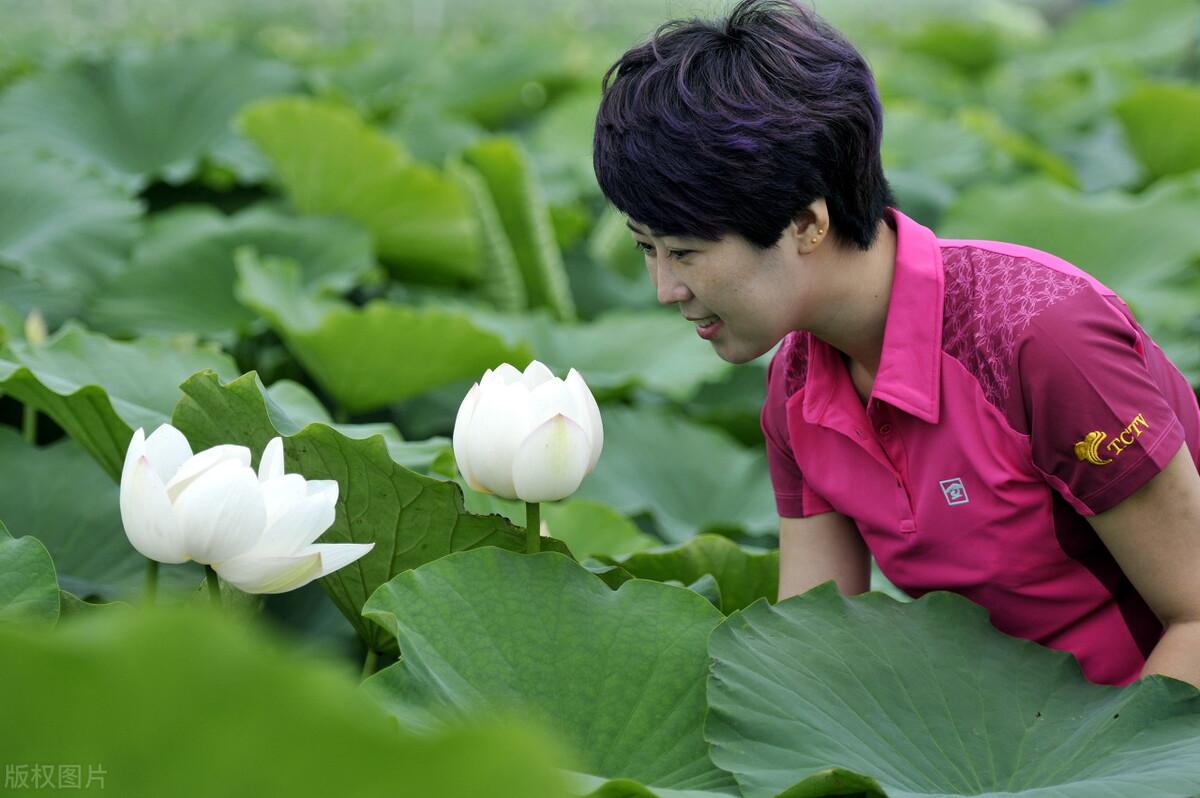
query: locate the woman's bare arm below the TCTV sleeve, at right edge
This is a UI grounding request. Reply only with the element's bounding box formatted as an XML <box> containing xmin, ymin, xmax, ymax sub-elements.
<box><xmin>1088</xmin><ymin>445</ymin><xmax>1200</xmax><ymax>686</ymax></box>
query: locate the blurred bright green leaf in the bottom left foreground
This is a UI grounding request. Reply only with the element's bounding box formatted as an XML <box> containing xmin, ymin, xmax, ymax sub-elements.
<box><xmin>0</xmin><ymin>606</ymin><xmax>568</xmax><ymax>798</ymax></box>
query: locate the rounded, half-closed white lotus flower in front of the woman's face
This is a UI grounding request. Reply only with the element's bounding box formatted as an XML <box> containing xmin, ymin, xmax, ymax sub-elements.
<box><xmin>454</xmin><ymin>360</ymin><xmax>604</xmax><ymax>502</ymax></box>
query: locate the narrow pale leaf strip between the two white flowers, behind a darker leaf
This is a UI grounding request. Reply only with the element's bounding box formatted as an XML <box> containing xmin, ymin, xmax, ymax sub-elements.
<box><xmin>266</xmin><ymin>379</ymin><xmax>451</xmax><ymax>474</ymax></box>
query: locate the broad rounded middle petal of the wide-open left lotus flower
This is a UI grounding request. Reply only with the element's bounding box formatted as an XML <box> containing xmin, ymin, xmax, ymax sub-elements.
<box><xmin>175</xmin><ymin>452</ymin><xmax>266</xmax><ymax>564</ymax></box>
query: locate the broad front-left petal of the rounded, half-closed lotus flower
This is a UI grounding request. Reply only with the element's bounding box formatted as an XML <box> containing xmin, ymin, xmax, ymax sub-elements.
<box><xmin>467</xmin><ymin>384</ymin><xmax>528</xmax><ymax>499</ymax></box>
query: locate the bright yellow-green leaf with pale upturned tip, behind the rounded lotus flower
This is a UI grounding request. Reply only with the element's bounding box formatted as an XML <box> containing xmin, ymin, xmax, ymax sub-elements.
<box><xmin>236</xmin><ymin>251</ymin><xmax>532</xmax><ymax>413</ymax></box>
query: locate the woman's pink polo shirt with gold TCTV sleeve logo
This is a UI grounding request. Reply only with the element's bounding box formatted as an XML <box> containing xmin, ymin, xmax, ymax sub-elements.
<box><xmin>761</xmin><ymin>210</ymin><xmax>1200</xmax><ymax>684</ymax></box>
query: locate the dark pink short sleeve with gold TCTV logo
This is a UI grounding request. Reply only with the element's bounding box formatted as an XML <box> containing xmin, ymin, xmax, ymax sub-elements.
<box><xmin>1016</xmin><ymin>288</ymin><xmax>1184</xmax><ymax>516</ymax></box>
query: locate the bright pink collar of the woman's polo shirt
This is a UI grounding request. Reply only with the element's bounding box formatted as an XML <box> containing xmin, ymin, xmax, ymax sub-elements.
<box><xmin>803</xmin><ymin>209</ymin><xmax>946</xmax><ymax>424</ymax></box>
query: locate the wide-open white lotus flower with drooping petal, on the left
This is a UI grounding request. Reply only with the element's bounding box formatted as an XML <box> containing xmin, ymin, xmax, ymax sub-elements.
<box><xmin>121</xmin><ymin>424</ymin><xmax>374</xmax><ymax>593</ymax></box>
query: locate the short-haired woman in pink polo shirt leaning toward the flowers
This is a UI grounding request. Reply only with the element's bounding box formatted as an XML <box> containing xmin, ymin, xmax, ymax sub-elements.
<box><xmin>594</xmin><ymin>0</ymin><xmax>1200</xmax><ymax>684</ymax></box>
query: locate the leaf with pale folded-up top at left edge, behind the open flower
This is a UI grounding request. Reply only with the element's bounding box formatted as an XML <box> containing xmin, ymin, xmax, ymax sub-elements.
<box><xmin>0</xmin><ymin>325</ymin><xmax>238</xmax><ymax>480</ymax></box>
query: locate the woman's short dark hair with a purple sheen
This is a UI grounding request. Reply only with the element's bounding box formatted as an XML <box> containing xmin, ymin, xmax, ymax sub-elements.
<box><xmin>593</xmin><ymin>0</ymin><xmax>895</xmax><ymax>250</ymax></box>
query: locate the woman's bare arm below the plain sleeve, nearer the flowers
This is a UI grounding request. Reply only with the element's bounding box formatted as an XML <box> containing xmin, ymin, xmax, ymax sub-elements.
<box><xmin>779</xmin><ymin>512</ymin><xmax>871</xmax><ymax>601</ymax></box>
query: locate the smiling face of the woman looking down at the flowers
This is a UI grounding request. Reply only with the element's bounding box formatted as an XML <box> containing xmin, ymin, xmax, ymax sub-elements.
<box><xmin>626</xmin><ymin>220</ymin><xmax>814</xmax><ymax>364</ymax></box>
